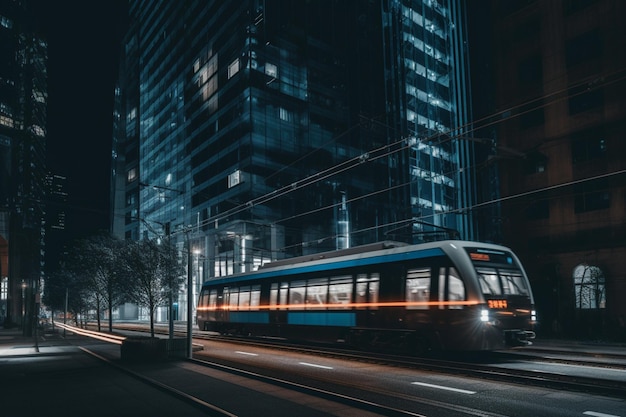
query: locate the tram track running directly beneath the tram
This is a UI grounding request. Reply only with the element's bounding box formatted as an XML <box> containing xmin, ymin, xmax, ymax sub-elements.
<box><xmin>90</xmin><ymin>324</ymin><xmax>626</xmax><ymax>398</ymax></box>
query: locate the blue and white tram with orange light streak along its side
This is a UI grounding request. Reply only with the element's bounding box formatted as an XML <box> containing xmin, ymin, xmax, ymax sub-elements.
<box><xmin>197</xmin><ymin>240</ymin><xmax>536</xmax><ymax>353</ymax></box>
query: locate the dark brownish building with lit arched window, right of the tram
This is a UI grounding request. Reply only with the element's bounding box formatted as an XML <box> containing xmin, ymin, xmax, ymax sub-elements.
<box><xmin>483</xmin><ymin>0</ymin><xmax>626</xmax><ymax>340</ymax></box>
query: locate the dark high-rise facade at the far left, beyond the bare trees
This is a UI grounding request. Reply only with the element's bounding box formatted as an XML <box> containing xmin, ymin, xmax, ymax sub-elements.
<box><xmin>0</xmin><ymin>1</ymin><xmax>47</xmax><ymax>333</ymax></box>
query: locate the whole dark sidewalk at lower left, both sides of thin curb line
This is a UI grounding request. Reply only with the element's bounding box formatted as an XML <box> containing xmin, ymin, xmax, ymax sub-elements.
<box><xmin>0</xmin><ymin>328</ymin><xmax>381</xmax><ymax>417</ymax></box>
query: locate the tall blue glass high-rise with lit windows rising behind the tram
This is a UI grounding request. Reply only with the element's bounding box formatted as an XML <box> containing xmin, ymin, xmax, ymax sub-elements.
<box><xmin>111</xmin><ymin>0</ymin><xmax>475</xmax><ymax>318</ymax></box>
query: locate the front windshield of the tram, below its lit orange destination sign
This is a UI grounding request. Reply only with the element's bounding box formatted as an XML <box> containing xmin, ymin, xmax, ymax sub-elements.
<box><xmin>466</xmin><ymin>248</ymin><xmax>530</xmax><ymax>296</ymax></box>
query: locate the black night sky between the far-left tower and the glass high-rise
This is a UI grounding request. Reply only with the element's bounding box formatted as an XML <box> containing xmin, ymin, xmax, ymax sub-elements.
<box><xmin>33</xmin><ymin>0</ymin><xmax>126</xmax><ymax>244</ymax></box>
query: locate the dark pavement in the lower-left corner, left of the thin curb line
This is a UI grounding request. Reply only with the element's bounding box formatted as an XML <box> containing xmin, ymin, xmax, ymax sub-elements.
<box><xmin>0</xmin><ymin>328</ymin><xmax>212</xmax><ymax>417</ymax></box>
